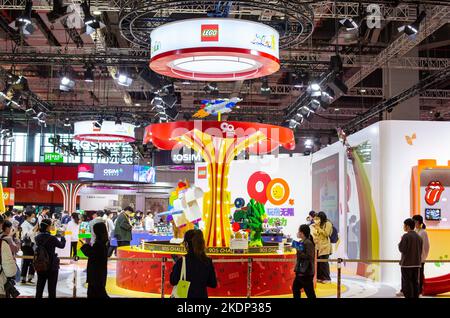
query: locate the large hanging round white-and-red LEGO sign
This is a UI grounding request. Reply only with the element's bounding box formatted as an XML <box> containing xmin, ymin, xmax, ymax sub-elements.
<box><xmin>150</xmin><ymin>18</ymin><xmax>280</xmax><ymax>81</ymax></box>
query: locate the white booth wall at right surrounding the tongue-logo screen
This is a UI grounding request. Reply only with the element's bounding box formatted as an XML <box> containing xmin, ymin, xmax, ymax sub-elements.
<box><xmin>313</xmin><ymin>121</ymin><xmax>450</xmax><ymax>284</ymax></box>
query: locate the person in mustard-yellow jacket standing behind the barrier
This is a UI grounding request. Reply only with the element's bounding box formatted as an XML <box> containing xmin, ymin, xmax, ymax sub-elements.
<box><xmin>311</xmin><ymin>211</ymin><xmax>333</xmax><ymax>283</ymax></box>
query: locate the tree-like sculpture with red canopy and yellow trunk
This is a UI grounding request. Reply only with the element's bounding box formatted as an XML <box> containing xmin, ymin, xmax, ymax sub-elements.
<box><xmin>144</xmin><ymin>121</ymin><xmax>295</xmax><ymax>247</ymax></box>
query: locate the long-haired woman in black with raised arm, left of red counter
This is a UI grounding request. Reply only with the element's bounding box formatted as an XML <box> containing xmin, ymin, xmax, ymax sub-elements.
<box><xmin>81</xmin><ymin>222</ymin><xmax>109</xmax><ymax>298</ymax></box>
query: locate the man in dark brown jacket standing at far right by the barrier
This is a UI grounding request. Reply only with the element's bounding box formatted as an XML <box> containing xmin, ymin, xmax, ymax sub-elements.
<box><xmin>398</xmin><ymin>219</ymin><xmax>423</xmax><ymax>298</ymax></box>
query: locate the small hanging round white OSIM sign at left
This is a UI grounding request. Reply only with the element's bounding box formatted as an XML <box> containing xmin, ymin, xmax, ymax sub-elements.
<box><xmin>74</xmin><ymin>120</ymin><xmax>136</xmax><ymax>142</ymax></box>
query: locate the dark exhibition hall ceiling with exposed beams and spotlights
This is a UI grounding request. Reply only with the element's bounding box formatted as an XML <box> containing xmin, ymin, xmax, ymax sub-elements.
<box><xmin>0</xmin><ymin>0</ymin><xmax>450</xmax><ymax>137</ymax></box>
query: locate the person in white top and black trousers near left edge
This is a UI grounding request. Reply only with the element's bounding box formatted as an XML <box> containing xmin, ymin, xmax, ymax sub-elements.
<box><xmin>20</xmin><ymin>209</ymin><xmax>37</xmax><ymax>284</ymax></box>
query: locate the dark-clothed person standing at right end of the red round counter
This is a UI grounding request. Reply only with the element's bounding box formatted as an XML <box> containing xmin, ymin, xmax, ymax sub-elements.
<box><xmin>292</xmin><ymin>224</ymin><xmax>316</xmax><ymax>298</ymax></box>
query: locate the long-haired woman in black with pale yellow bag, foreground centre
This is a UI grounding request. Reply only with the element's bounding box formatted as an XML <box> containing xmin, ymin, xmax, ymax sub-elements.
<box><xmin>170</xmin><ymin>230</ymin><xmax>217</xmax><ymax>298</ymax></box>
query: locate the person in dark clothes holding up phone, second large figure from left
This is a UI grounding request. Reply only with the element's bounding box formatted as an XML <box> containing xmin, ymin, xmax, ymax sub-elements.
<box><xmin>34</xmin><ymin>219</ymin><xmax>66</xmax><ymax>298</ymax></box>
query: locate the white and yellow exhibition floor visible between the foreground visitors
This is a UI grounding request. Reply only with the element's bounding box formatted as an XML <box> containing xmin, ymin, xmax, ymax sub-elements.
<box><xmin>17</xmin><ymin>261</ymin><xmax>450</xmax><ymax>298</ymax></box>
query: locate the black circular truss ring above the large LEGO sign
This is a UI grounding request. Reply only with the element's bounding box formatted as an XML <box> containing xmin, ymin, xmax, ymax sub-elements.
<box><xmin>119</xmin><ymin>0</ymin><xmax>314</xmax><ymax>49</ymax></box>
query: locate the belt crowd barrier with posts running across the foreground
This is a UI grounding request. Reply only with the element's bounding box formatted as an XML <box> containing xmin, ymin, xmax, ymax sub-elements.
<box><xmin>16</xmin><ymin>256</ymin><xmax>450</xmax><ymax>298</ymax></box>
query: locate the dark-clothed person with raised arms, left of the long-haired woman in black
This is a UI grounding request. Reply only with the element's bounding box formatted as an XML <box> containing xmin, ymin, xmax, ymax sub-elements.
<box><xmin>35</xmin><ymin>219</ymin><xmax>66</xmax><ymax>298</ymax></box>
